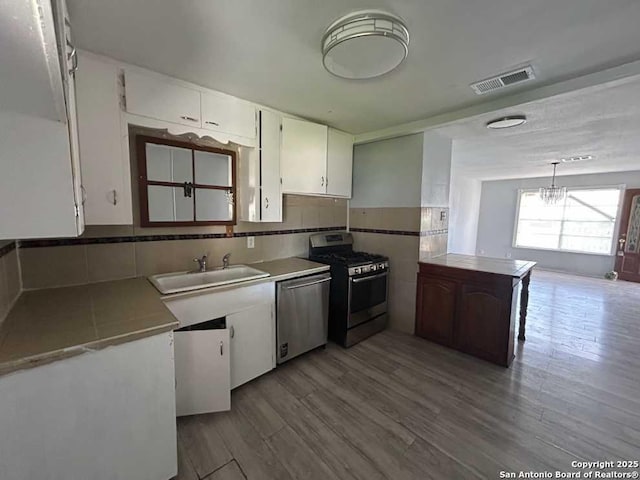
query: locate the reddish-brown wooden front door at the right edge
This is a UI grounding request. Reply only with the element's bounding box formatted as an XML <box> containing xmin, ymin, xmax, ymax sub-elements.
<box><xmin>616</xmin><ymin>189</ymin><xmax>640</xmax><ymax>282</ymax></box>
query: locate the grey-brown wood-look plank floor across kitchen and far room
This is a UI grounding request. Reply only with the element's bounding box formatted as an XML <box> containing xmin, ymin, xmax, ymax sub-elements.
<box><xmin>172</xmin><ymin>271</ymin><xmax>640</xmax><ymax>480</ymax></box>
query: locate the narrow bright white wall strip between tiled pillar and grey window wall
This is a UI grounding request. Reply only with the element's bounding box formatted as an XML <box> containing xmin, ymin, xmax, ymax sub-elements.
<box><xmin>447</xmin><ymin>169</ymin><xmax>482</xmax><ymax>255</ymax></box>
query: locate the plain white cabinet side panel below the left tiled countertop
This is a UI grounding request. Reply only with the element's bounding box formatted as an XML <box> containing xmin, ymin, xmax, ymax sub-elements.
<box><xmin>0</xmin><ymin>332</ymin><xmax>178</xmax><ymax>480</ymax></box>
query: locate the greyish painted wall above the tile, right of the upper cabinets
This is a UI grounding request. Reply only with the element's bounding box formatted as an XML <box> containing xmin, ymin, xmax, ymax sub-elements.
<box><xmin>350</xmin><ymin>133</ymin><xmax>424</xmax><ymax>208</ymax></box>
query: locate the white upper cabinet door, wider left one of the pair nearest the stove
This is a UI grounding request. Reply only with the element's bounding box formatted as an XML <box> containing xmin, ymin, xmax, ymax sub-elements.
<box><xmin>280</xmin><ymin>118</ymin><xmax>327</xmax><ymax>195</ymax></box>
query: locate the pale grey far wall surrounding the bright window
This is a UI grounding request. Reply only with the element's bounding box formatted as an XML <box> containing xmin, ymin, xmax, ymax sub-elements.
<box><xmin>476</xmin><ymin>171</ymin><xmax>640</xmax><ymax>277</ymax></box>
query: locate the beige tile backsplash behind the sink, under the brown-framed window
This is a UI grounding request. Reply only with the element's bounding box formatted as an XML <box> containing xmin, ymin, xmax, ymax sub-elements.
<box><xmin>20</xmin><ymin>195</ymin><xmax>347</xmax><ymax>289</ymax></box>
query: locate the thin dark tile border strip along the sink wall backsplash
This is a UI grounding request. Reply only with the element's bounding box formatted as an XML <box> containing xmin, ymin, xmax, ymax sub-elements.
<box><xmin>20</xmin><ymin>226</ymin><xmax>347</xmax><ymax>249</ymax></box>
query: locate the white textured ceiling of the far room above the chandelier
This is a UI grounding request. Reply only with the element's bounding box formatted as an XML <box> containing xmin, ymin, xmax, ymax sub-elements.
<box><xmin>436</xmin><ymin>76</ymin><xmax>640</xmax><ymax>180</ymax></box>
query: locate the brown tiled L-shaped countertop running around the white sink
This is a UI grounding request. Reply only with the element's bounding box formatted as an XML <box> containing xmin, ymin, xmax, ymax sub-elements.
<box><xmin>0</xmin><ymin>258</ymin><xmax>329</xmax><ymax>376</ymax></box>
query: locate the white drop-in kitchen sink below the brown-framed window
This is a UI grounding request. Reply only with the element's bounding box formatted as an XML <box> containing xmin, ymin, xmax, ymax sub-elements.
<box><xmin>149</xmin><ymin>265</ymin><xmax>269</xmax><ymax>295</ymax></box>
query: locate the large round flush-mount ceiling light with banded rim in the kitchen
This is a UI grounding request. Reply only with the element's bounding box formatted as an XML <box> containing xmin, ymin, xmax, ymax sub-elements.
<box><xmin>322</xmin><ymin>10</ymin><xmax>409</xmax><ymax>80</ymax></box>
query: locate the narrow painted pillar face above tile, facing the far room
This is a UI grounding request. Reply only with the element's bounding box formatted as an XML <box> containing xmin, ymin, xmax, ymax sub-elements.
<box><xmin>421</xmin><ymin>132</ymin><xmax>452</xmax><ymax>208</ymax></box>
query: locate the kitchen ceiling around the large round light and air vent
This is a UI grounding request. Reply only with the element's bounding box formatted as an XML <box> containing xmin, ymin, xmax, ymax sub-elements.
<box><xmin>68</xmin><ymin>0</ymin><xmax>640</xmax><ymax>135</ymax></box>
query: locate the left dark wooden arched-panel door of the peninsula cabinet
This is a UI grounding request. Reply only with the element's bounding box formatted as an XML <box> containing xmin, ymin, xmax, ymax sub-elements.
<box><xmin>416</xmin><ymin>276</ymin><xmax>456</xmax><ymax>346</ymax></box>
